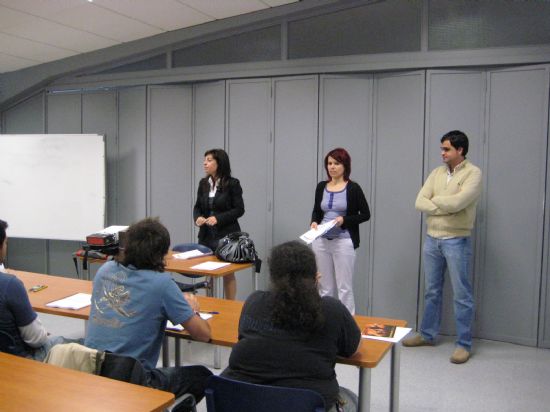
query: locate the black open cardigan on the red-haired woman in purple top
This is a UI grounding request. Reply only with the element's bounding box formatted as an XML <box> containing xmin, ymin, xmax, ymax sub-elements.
<box><xmin>311</xmin><ymin>180</ymin><xmax>370</xmax><ymax>249</ymax></box>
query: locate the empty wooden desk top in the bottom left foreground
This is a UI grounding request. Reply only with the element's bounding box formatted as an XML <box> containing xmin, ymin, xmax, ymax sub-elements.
<box><xmin>0</xmin><ymin>353</ymin><xmax>174</xmax><ymax>412</ymax></box>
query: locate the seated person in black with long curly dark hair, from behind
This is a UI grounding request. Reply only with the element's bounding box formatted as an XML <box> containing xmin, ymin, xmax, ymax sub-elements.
<box><xmin>222</xmin><ymin>241</ymin><xmax>361</xmax><ymax>412</ymax></box>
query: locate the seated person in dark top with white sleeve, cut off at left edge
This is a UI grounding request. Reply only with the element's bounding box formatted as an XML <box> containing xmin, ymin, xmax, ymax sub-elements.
<box><xmin>0</xmin><ymin>220</ymin><xmax>81</xmax><ymax>361</ymax></box>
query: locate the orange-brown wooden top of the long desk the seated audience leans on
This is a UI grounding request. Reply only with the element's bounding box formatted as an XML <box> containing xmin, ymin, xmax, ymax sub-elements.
<box><xmin>11</xmin><ymin>270</ymin><xmax>407</xmax><ymax>368</ymax></box>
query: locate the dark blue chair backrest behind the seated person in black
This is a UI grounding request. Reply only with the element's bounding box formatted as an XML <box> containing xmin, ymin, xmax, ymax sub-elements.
<box><xmin>205</xmin><ymin>376</ymin><xmax>325</xmax><ymax>412</ymax></box>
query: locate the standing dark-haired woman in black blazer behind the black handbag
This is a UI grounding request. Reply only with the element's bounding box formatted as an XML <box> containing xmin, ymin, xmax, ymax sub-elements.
<box><xmin>193</xmin><ymin>149</ymin><xmax>244</xmax><ymax>300</ymax></box>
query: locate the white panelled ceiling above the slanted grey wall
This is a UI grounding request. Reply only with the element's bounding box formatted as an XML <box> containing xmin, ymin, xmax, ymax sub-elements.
<box><xmin>0</xmin><ymin>0</ymin><xmax>298</xmax><ymax>73</ymax></box>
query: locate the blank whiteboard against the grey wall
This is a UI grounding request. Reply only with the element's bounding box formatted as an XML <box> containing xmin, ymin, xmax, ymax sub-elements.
<box><xmin>0</xmin><ymin>134</ymin><xmax>105</xmax><ymax>241</ymax></box>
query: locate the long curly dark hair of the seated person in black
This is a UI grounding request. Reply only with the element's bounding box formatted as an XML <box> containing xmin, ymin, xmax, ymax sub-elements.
<box><xmin>268</xmin><ymin>241</ymin><xmax>325</xmax><ymax>333</ymax></box>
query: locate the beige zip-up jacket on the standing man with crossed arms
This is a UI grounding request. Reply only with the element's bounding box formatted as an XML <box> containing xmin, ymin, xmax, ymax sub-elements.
<box><xmin>415</xmin><ymin>160</ymin><xmax>481</xmax><ymax>239</ymax></box>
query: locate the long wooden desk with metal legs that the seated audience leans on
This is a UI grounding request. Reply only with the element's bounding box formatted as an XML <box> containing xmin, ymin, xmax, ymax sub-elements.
<box><xmin>11</xmin><ymin>271</ymin><xmax>407</xmax><ymax>412</ymax></box>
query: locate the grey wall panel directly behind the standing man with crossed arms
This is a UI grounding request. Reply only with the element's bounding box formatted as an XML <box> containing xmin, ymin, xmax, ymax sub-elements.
<box><xmin>424</xmin><ymin>70</ymin><xmax>485</xmax><ymax>334</ymax></box>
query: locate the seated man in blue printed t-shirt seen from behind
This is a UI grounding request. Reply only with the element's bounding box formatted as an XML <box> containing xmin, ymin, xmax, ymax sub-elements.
<box><xmin>85</xmin><ymin>218</ymin><xmax>212</xmax><ymax>410</ymax></box>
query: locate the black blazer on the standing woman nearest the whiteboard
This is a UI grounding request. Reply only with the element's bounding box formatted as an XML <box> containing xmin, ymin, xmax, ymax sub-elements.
<box><xmin>193</xmin><ymin>177</ymin><xmax>244</xmax><ymax>242</ymax></box>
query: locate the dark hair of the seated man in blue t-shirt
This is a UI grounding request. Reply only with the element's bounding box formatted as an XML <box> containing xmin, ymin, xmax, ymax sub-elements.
<box><xmin>122</xmin><ymin>217</ymin><xmax>170</xmax><ymax>272</ymax></box>
